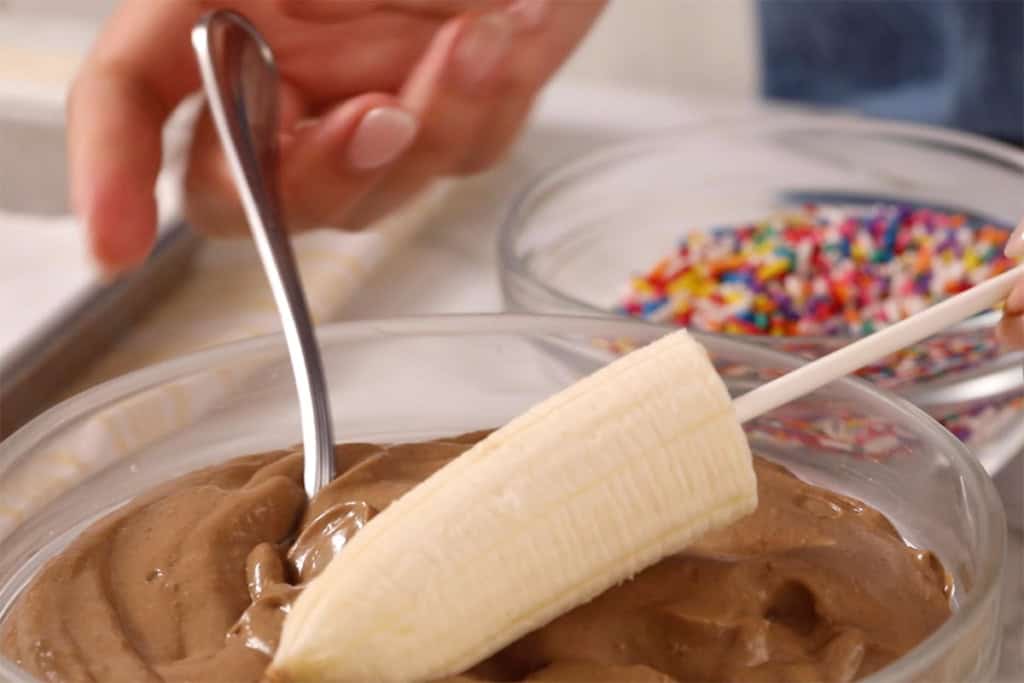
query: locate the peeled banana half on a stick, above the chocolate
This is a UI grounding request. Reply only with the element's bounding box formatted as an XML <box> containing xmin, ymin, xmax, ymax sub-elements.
<box><xmin>270</xmin><ymin>332</ymin><xmax>757</xmax><ymax>683</ymax></box>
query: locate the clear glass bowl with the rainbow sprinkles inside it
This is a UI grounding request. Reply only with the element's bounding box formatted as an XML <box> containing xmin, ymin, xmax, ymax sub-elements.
<box><xmin>499</xmin><ymin>114</ymin><xmax>1024</xmax><ymax>473</ymax></box>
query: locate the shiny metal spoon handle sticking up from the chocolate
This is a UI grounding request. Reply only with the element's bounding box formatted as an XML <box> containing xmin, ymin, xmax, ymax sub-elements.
<box><xmin>191</xmin><ymin>10</ymin><xmax>334</xmax><ymax>498</ymax></box>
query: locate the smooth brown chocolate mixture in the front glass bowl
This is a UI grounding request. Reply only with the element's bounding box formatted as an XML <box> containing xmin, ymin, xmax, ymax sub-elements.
<box><xmin>0</xmin><ymin>433</ymin><xmax>950</xmax><ymax>683</ymax></box>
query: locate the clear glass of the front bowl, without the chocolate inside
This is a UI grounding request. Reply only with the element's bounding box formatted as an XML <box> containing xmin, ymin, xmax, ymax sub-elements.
<box><xmin>0</xmin><ymin>315</ymin><xmax>1006</xmax><ymax>682</ymax></box>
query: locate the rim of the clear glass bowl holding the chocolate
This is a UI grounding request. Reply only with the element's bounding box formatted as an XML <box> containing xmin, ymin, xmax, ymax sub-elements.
<box><xmin>0</xmin><ymin>313</ymin><xmax>1007</xmax><ymax>683</ymax></box>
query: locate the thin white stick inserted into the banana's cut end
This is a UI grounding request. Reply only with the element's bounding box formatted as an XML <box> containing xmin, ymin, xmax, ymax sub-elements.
<box><xmin>732</xmin><ymin>264</ymin><xmax>1024</xmax><ymax>422</ymax></box>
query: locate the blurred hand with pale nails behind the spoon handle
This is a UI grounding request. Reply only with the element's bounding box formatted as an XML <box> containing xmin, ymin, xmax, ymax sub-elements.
<box><xmin>69</xmin><ymin>0</ymin><xmax>604</xmax><ymax>271</ymax></box>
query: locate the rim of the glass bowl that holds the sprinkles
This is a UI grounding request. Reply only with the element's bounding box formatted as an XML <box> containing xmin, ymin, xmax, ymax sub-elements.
<box><xmin>497</xmin><ymin>109</ymin><xmax>1024</xmax><ymax>350</ymax></box>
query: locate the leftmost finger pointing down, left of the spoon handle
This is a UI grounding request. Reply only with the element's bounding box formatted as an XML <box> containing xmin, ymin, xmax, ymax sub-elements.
<box><xmin>68</xmin><ymin>0</ymin><xmax>198</xmax><ymax>272</ymax></box>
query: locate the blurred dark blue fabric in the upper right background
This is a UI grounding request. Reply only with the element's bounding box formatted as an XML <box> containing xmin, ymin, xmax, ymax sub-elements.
<box><xmin>758</xmin><ymin>0</ymin><xmax>1024</xmax><ymax>144</ymax></box>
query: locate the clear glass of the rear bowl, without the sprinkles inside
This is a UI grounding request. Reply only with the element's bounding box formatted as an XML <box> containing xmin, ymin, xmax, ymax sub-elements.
<box><xmin>499</xmin><ymin>113</ymin><xmax>1024</xmax><ymax>430</ymax></box>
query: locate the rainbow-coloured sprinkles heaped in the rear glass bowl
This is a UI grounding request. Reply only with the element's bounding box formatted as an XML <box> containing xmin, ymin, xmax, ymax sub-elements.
<box><xmin>617</xmin><ymin>204</ymin><xmax>1015</xmax><ymax>387</ymax></box>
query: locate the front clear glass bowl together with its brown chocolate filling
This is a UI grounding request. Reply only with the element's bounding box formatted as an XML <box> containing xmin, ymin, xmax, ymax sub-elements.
<box><xmin>0</xmin><ymin>315</ymin><xmax>1006</xmax><ymax>683</ymax></box>
